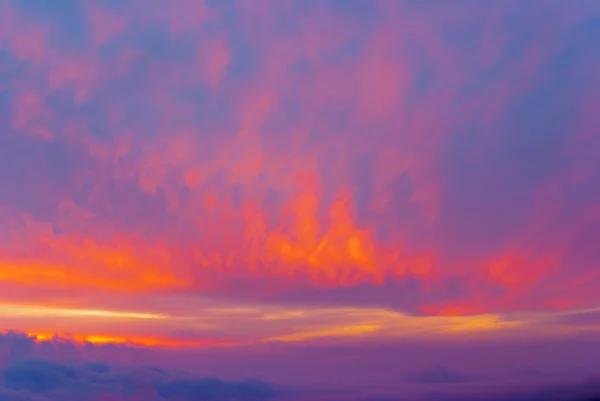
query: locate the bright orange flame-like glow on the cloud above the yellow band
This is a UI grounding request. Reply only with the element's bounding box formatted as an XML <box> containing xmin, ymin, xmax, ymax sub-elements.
<box><xmin>0</xmin><ymin>180</ymin><xmax>422</xmax><ymax>292</ymax></box>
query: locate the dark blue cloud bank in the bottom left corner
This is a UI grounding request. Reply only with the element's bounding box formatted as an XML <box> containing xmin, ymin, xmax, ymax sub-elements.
<box><xmin>0</xmin><ymin>359</ymin><xmax>280</xmax><ymax>401</ymax></box>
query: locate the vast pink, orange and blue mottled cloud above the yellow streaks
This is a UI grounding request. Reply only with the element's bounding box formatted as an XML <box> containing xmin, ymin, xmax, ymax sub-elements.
<box><xmin>0</xmin><ymin>0</ymin><xmax>600</xmax><ymax>344</ymax></box>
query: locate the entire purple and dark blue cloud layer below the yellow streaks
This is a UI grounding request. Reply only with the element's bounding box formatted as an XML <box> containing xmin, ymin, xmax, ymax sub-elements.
<box><xmin>0</xmin><ymin>333</ymin><xmax>600</xmax><ymax>401</ymax></box>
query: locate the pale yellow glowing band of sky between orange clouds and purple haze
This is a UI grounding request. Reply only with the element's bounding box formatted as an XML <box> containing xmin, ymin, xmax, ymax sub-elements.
<box><xmin>0</xmin><ymin>300</ymin><xmax>535</xmax><ymax>346</ymax></box>
